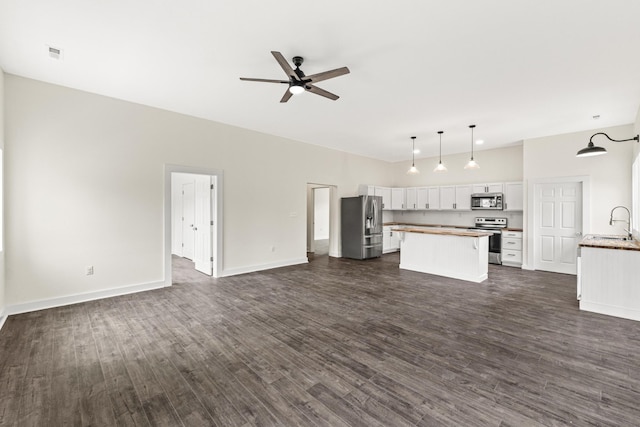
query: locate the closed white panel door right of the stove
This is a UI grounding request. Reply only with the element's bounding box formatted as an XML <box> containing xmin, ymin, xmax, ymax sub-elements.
<box><xmin>534</xmin><ymin>182</ymin><xmax>582</xmax><ymax>274</ymax></box>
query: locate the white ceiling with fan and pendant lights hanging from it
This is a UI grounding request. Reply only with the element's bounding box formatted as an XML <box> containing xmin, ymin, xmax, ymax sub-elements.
<box><xmin>0</xmin><ymin>0</ymin><xmax>640</xmax><ymax>162</ymax></box>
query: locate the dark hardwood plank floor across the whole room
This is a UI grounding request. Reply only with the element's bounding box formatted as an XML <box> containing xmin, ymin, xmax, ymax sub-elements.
<box><xmin>0</xmin><ymin>254</ymin><xmax>640</xmax><ymax>426</ymax></box>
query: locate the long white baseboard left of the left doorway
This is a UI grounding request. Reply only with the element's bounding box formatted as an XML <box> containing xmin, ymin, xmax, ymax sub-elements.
<box><xmin>5</xmin><ymin>281</ymin><xmax>168</xmax><ymax>316</ymax></box>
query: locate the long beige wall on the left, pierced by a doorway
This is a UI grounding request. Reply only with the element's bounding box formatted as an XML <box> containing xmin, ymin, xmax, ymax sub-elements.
<box><xmin>5</xmin><ymin>75</ymin><xmax>391</xmax><ymax>305</ymax></box>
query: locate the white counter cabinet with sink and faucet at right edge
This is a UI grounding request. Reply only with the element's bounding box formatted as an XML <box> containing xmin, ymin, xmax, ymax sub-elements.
<box><xmin>578</xmin><ymin>234</ymin><xmax>640</xmax><ymax>320</ymax></box>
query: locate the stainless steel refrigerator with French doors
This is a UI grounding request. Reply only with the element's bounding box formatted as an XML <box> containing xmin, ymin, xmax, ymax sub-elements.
<box><xmin>340</xmin><ymin>196</ymin><xmax>382</xmax><ymax>259</ymax></box>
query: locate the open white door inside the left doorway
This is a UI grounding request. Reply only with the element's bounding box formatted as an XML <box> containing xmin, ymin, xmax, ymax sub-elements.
<box><xmin>194</xmin><ymin>175</ymin><xmax>213</xmax><ymax>276</ymax></box>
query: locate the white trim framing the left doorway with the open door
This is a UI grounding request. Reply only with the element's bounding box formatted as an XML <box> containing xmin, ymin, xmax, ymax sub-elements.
<box><xmin>164</xmin><ymin>164</ymin><xmax>224</xmax><ymax>286</ymax></box>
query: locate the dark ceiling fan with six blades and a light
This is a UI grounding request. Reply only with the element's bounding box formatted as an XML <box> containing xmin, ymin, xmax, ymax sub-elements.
<box><xmin>240</xmin><ymin>51</ymin><xmax>349</xmax><ymax>102</ymax></box>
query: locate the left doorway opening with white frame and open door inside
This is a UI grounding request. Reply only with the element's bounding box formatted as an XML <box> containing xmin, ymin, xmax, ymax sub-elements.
<box><xmin>165</xmin><ymin>166</ymin><xmax>222</xmax><ymax>286</ymax></box>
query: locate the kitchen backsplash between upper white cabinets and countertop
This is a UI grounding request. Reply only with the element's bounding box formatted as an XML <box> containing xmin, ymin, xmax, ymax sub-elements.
<box><xmin>390</xmin><ymin>210</ymin><xmax>523</xmax><ymax>228</ymax></box>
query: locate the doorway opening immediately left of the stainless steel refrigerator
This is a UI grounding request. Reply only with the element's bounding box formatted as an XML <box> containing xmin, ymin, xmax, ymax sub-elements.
<box><xmin>307</xmin><ymin>184</ymin><xmax>338</xmax><ymax>256</ymax></box>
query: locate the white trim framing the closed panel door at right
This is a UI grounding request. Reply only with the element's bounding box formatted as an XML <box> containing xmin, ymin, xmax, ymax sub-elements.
<box><xmin>522</xmin><ymin>175</ymin><xmax>591</xmax><ymax>270</ymax></box>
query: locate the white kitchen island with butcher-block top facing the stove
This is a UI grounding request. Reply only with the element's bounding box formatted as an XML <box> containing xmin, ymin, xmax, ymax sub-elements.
<box><xmin>393</xmin><ymin>227</ymin><xmax>490</xmax><ymax>283</ymax></box>
